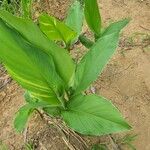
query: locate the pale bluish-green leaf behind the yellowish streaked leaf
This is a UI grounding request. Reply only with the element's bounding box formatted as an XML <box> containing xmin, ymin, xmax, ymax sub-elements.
<box><xmin>65</xmin><ymin>0</ymin><xmax>84</xmax><ymax>42</ymax></box>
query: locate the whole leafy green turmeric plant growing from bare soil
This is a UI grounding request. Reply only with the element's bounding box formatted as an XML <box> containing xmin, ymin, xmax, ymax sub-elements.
<box><xmin>0</xmin><ymin>0</ymin><xmax>131</xmax><ymax>135</ymax></box>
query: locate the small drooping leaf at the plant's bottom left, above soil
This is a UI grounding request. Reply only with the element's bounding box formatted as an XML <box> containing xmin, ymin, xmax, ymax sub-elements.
<box><xmin>14</xmin><ymin>104</ymin><xmax>34</xmax><ymax>132</ymax></box>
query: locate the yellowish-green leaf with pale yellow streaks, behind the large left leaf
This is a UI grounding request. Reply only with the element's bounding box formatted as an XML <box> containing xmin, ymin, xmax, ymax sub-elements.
<box><xmin>39</xmin><ymin>14</ymin><xmax>76</xmax><ymax>45</ymax></box>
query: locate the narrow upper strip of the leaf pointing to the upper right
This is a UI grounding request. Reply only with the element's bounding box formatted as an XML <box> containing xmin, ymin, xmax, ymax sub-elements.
<box><xmin>101</xmin><ymin>19</ymin><xmax>130</xmax><ymax>36</ymax></box>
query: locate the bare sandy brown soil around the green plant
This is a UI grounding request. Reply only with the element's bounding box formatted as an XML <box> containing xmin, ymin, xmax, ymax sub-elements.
<box><xmin>0</xmin><ymin>0</ymin><xmax>150</xmax><ymax>150</ymax></box>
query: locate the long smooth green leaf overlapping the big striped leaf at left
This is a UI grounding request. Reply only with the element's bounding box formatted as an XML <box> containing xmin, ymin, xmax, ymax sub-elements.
<box><xmin>0</xmin><ymin>11</ymin><xmax>75</xmax><ymax>84</ymax></box>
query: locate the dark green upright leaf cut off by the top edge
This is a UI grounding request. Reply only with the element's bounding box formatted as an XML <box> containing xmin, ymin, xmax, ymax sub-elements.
<box><xmin>84</xmin><ymin>0</ymin><xmax>101</xmax><ymax>36</ymax></box>
